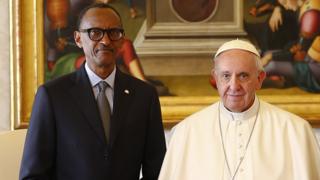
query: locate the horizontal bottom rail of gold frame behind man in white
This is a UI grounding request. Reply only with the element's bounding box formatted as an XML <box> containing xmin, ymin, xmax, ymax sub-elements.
<box><xmin>160</xmin><ymin>94</ymin><xmax>320</xmax><ymax>128</ymax></box>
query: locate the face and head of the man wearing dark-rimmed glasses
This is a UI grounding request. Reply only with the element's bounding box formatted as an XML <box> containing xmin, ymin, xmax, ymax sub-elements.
<box><xmin>75</xmin><ymin>8</ymin><xmax>122</xmax><ymax>74</ymax></box>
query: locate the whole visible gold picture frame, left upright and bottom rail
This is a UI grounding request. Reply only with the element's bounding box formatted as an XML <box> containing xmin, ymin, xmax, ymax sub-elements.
<box><xmin>10</xmin><ymin>0</ymin><xmax>320</xmax><ymax>129</ymax></box>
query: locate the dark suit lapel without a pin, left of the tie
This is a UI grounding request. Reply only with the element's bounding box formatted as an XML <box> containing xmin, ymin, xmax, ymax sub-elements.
<box><xmin>69</xmin><ymin>65</ymin><xmax>106</xmax><ymax>143</ymax></box>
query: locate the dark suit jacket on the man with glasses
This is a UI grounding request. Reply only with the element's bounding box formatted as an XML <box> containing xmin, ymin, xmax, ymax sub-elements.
<box><xmin>20</xmin><ymin>66</ymin><xmax>166</xmax><ymax>180</ymax></box>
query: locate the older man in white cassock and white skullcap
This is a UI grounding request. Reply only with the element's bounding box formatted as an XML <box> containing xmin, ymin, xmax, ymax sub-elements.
<box><xmin>159</xmin><ymin>40</ymin><xmax>320</xmax><ymax>180</ymax></box>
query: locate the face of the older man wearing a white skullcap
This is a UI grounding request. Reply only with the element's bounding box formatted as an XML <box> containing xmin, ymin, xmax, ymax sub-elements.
<box><xmin>212</xmin><ymin>49</ymin><xmax>265</xmax><ymax>112</ymax></box>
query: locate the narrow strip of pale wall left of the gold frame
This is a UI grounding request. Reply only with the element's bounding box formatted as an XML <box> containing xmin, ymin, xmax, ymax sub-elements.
<box><xmin>0</xmin><ymin>0</ymin><xmax>10</xmax><ymax>131</ymax></box>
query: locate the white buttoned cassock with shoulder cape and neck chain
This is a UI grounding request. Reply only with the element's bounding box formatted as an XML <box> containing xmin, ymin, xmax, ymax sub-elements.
<box><xmin>159</xmin><ymin>97</ymin><xmax>320</xmax><ymax>180</ymax></box>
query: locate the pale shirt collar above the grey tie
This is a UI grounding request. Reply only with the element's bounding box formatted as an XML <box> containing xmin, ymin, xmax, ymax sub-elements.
<box><xmin>85</xmin><ymin>62</ymin><xmax>117</xmax><ymax>89</ymax></box>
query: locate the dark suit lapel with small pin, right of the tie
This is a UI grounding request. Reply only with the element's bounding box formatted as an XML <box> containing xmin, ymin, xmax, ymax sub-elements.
<box><xmin>110</xmin><ymin>69</ymin><xmax>134</xmax><ymax>146</ymax></box>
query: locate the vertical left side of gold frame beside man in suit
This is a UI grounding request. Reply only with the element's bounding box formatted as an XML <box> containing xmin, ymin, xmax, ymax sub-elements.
<box><xmin>9</xmin><ymin>0</ymin><xmax>44</xmax><ymax>129</ymax></box>
